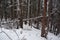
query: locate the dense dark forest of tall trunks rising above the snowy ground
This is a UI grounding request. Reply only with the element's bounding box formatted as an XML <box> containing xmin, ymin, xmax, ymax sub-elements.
<box><xmin>0</xmin><ymin>0</ymin><xmax>60</xmax><ymax>38</ymax></box>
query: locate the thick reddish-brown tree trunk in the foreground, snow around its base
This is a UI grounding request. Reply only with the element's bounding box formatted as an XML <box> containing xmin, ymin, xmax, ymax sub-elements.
<box><xmin>41</xmin><ymin>0</ymin><xmax>47</xmax><ymax>38</ymax></box>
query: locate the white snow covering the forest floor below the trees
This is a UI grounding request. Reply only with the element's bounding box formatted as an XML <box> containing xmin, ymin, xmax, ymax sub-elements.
<box><xmin>0</xmin><ymin>19</ymin><xmax>60</xmax><ymax>40</ymax></box>
